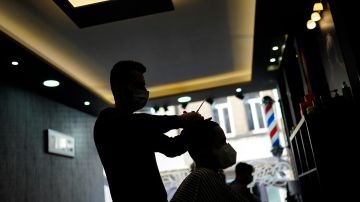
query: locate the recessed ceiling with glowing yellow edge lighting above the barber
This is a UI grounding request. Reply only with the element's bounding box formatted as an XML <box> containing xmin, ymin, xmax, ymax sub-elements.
<box><xmin>0</xmin><ymin>0</ymin><xmax>305</xmax><ymax>114</ymax></box>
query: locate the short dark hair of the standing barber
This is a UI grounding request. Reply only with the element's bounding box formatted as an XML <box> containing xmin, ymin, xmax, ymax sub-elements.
<box><xmin>110</xmin><ymin>60</ymin><xmax>146</xmax><ymax>93</ymax></box>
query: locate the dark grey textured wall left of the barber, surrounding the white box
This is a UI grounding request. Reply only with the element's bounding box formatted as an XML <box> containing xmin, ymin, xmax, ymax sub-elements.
<box><xmin>0</xmin><ymin>84</ymin><xmax>104</xmax><ymax>202</ymax></box>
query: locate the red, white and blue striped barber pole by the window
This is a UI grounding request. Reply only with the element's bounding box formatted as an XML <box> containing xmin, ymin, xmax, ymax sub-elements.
<box><xmin>263</xmin><ymin>96</ymin><xmax>283</xmax><ymax>157</ymax></box>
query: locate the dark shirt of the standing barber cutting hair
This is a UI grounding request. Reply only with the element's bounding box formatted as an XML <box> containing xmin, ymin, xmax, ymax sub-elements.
<box><xmin>94</xmin><ymin>108</ymin><xmax>186</xmax><ymax>202</ymax></box>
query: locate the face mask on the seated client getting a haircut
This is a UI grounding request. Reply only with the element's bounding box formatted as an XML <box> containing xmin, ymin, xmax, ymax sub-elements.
<box><xmin>214</xmin><ymin>143</ymin><xmax>236</xmax><ymax>169</ymax></box>
